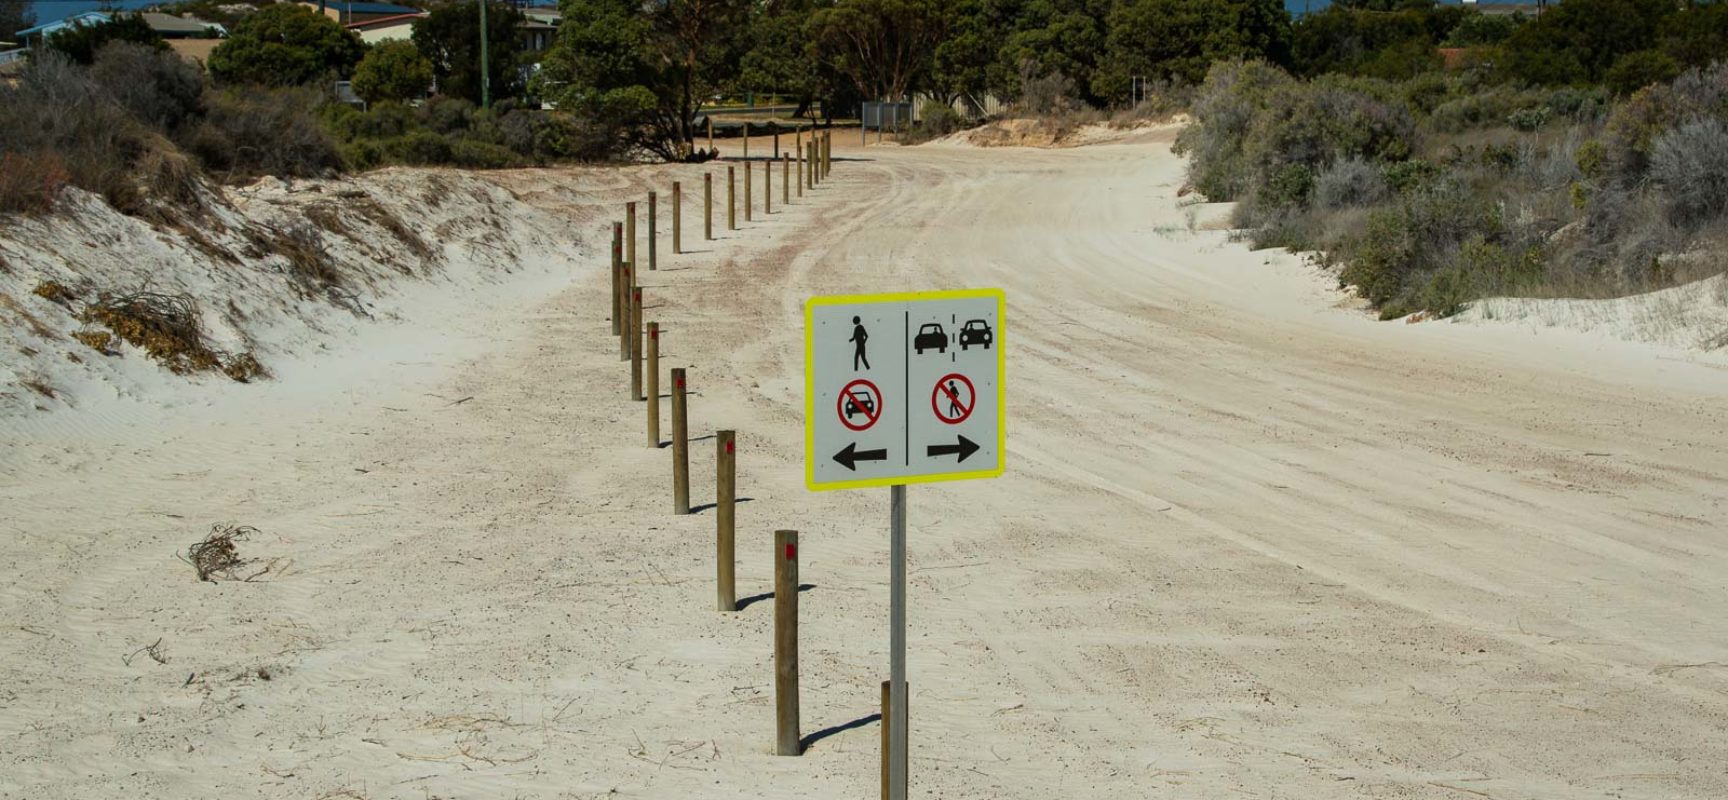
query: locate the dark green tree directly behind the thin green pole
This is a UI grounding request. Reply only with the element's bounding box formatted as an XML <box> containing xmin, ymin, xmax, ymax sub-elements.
<box><xmin>415</xmin><ymin>2</ymin><xmax>524</xmax><ymax>104</ymax></box>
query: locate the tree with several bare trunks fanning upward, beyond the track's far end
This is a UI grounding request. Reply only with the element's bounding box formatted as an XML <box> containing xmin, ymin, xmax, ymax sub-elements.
<box><xmin>810</xmin><ymin>0</ymin><xmax>949</xmax><ymax>100</ymax></box>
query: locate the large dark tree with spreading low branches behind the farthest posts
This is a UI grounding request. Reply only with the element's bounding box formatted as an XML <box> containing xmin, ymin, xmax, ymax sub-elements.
<box><xmin>539</xmin><ymin>0</ymin><xmax>753</xmax><ymax>161</ymax></box>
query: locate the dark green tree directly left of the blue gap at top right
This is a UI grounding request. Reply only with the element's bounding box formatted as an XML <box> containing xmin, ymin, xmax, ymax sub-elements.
<box><xmin>1092</xmin><ymin>0</ymin><xmax>1291</xmax><ymax>98</ymax></box>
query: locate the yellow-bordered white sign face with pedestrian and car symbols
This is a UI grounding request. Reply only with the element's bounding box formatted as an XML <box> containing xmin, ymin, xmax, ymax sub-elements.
<box><xmin>804</xmin><ymin>289</ymin><xmax>1007</xmax><ymax>491</ymax></box>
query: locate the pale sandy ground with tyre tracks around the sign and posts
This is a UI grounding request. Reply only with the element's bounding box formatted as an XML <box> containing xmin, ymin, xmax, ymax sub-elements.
<box><xmin>0</xmin><ymin>137</ymin><xmax>1728</xmax><ymax>800</ymax></box>
